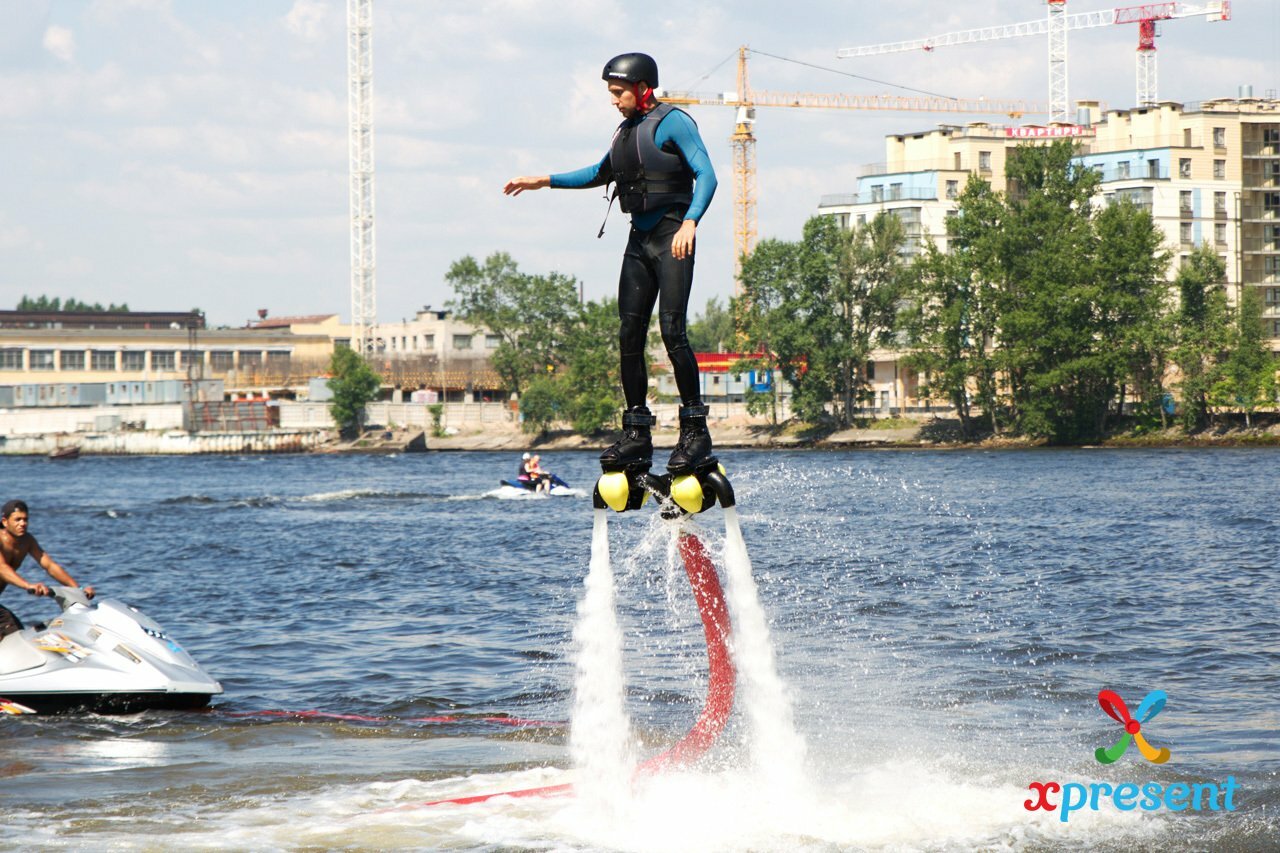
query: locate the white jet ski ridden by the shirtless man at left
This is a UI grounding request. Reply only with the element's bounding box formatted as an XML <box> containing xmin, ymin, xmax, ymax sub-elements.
<box><xmin>0</xmin><ymin>587</ymin><xmax>223</xmax><ymax>713</ymax></box>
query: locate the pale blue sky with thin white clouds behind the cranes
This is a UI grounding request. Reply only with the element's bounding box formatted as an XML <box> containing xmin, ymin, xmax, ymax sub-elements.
<box><xmin>0</xmin><ymin>0</ymin><xmax>1280</xmax><ymax>327</ymax></box>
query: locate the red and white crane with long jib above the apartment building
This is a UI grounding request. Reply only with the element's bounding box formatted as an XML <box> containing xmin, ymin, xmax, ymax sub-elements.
<box><xmin>836</xmin><ymin>0</ymin><xmax>1231</xmax><ymax>123</ymax></box>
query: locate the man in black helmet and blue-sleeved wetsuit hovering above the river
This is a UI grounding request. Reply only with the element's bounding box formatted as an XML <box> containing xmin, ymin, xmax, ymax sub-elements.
<box><xmin>503</xmin><ymin>54</ymin><xmax>717</xmax><ymax>474</ymax></box>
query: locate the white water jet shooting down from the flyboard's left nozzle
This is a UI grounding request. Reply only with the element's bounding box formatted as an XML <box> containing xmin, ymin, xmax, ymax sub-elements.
<box><xmin>570</xmin><ymin>510</ymin><xmax>635</xmax><ymax>813</ymax></box>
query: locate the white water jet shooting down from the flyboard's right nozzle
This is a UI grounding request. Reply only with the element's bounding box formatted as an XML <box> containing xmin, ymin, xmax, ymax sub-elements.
<box><xmin>724</xmin><ymin>507</ymin><xmax>805</xmax><ymax>792</ymax></box>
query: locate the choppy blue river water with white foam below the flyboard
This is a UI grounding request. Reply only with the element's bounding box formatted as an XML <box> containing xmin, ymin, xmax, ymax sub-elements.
<box><xmin>0</xmin><ymin>450</ymin><xmax>1280</xmax><ymax>850</ymax></box>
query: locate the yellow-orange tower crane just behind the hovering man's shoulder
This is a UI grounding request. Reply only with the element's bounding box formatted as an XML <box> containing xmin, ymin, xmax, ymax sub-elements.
<box><xmin>660</xmin><ymin>46</ymin><xmax>1047</xmax><ymax>279</ymax></box>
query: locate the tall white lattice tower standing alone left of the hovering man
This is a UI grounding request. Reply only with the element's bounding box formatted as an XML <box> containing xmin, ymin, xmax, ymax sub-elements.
<box><xmin>347</xmin><ymin>0</ymin><xmax>378</xmax><ymax>356</ymax></box>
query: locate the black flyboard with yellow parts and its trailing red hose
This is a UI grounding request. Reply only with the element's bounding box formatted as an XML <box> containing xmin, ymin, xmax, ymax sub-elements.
<box><xmin>417</xmin><ymin>457</ymin><xmax>736</xmax><ymax>811</ymax></box>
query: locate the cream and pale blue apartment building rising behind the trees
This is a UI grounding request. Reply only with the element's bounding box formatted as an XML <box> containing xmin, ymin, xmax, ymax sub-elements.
<box><xmin>818</xmin><ymin>95</ymin><xmax>1280</xmax><ymax>350</ymax></box>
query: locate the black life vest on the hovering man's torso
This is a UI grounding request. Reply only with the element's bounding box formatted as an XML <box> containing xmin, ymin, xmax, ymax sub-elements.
<box><xmin>609</xmin><ymin>104</ymin><xmax>694</xmax><ymax>214</ymax></box>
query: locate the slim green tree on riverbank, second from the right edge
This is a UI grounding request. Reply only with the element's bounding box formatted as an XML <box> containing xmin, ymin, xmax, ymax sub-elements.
<box><xmin>1172</xmin><ymin>246</ymin><xmax>1231</xmax><ymax>430</ymax></box>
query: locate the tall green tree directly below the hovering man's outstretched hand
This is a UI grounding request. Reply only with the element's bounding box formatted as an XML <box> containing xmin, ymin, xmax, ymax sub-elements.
<box><xmin>444</xmin><ymin>252</ymin><xmax>576</xmax><ymax>394</ymax></box>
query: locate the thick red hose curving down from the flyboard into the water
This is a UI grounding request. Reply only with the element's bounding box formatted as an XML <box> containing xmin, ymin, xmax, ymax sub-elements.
<box><xmin>417</xmin><ymin>533</ymin><xmax>735</xmax><ymax>808</ymax></box>
